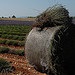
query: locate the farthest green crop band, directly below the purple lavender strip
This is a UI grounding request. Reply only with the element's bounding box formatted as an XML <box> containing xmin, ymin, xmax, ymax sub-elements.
<box><xmin>0</xmin><ymin>25</ymin><xmax>31</xmax><ymax>33</ymax></box>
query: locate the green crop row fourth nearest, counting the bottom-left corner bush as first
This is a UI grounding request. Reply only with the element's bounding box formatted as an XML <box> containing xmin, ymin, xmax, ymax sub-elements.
<box><xmin>0</xmin><ymin>34</ymin><xmax>25</xmax><ymax>41</ymax></box>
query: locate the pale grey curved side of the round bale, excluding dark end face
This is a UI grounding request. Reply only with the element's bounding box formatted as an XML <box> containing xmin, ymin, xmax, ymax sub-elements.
<box><xmin>25</xmin><ymin>27</ymin><xmax>60</xmax><ymax>71</ymax></box>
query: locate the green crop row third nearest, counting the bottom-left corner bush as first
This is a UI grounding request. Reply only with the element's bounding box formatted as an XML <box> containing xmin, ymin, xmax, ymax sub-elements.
<box><xmin>0</xmin><ymin>39</ymin><xmax>25</xmax><ymax>46</ymax></box>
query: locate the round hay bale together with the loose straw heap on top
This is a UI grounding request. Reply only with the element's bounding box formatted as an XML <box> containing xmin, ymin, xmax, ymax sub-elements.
<box><xmin>25</xmin><ymin>5</ymin><xmax>75</xmax><ymax>75</ymax></box>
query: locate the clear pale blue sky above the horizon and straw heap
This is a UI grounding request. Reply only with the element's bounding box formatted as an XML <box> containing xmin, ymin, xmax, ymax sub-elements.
<box><xmin>0</xmin><ymin>0</ymin><xmax>75</xmax><ymax>17</ymax></box>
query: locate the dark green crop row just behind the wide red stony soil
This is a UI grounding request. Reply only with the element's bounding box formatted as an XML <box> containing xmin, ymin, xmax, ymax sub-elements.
<box><xmin>0</xmin><ymin>47</ymin><xmax>24</xmax><ymax>56</ymax></box>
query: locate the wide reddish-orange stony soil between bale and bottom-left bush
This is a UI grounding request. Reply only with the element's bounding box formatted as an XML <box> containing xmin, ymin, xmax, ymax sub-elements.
<box><xmin>0</xmin><ymin>54</ymin><xmax>46</xmax><ymax>75</ymax></box>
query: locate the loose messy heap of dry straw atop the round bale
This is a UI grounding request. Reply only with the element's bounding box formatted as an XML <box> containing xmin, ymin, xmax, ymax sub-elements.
<box><xmin>33</xmin><ymin>4</ymin><xmax>72</xmax><ymax>30</ymax></box>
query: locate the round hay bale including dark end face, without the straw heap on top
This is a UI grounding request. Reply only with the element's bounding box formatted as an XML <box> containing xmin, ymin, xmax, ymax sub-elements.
<box><xmin>25</xmin><ymin>25</ymin><xmax>75</xmax><ymax>75</ymax></box>
